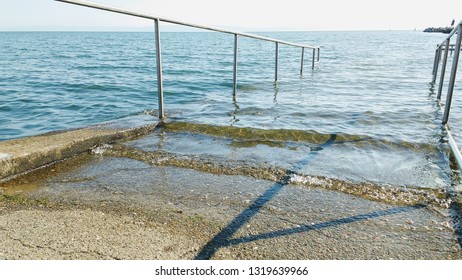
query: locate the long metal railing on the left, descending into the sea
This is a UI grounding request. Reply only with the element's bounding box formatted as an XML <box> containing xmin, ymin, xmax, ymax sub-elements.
<box><xmin>55</xmin><ymin>0</ymin><xmax>320</xmax><ymax>119</ymax></box>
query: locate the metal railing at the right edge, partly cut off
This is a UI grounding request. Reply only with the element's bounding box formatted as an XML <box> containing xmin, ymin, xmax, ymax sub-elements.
<box><xmin>433</xmin><ymin>21</ymin><xmax>462</xmax><ymax>171</ymax></box>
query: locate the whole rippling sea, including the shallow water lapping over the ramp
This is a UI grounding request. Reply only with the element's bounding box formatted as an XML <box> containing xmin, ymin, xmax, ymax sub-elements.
<box><xmin>0</xmin><ymin>31</ymin><xmax>462</xmax><ymax>192</ymax></box>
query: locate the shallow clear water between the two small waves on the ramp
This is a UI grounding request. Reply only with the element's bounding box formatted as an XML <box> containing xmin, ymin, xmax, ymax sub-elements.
<box><xmin>123</xmin><ymin>123</ymin><xmax>450</xmax><ymax>189</ymax></box>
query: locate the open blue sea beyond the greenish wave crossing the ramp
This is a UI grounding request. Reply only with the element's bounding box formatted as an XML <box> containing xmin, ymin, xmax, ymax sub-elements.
<box><xmin>0</xmin><ymin>31</ymin><xmax>450</xmax><ymax>142</ymax></box>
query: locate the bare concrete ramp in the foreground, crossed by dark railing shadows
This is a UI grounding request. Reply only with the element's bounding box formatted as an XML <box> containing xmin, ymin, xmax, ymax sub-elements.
<box><xmin>0</xmin><ymin>155</ymin><xmax>462</xmax><ymax>259</ymax></box>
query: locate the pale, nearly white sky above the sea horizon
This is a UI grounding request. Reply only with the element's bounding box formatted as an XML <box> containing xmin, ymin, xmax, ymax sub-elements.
<box><xmin>0</xmin><ymin>0</ymin><xmax>462</xmax><ymax>31</ymax></box>
